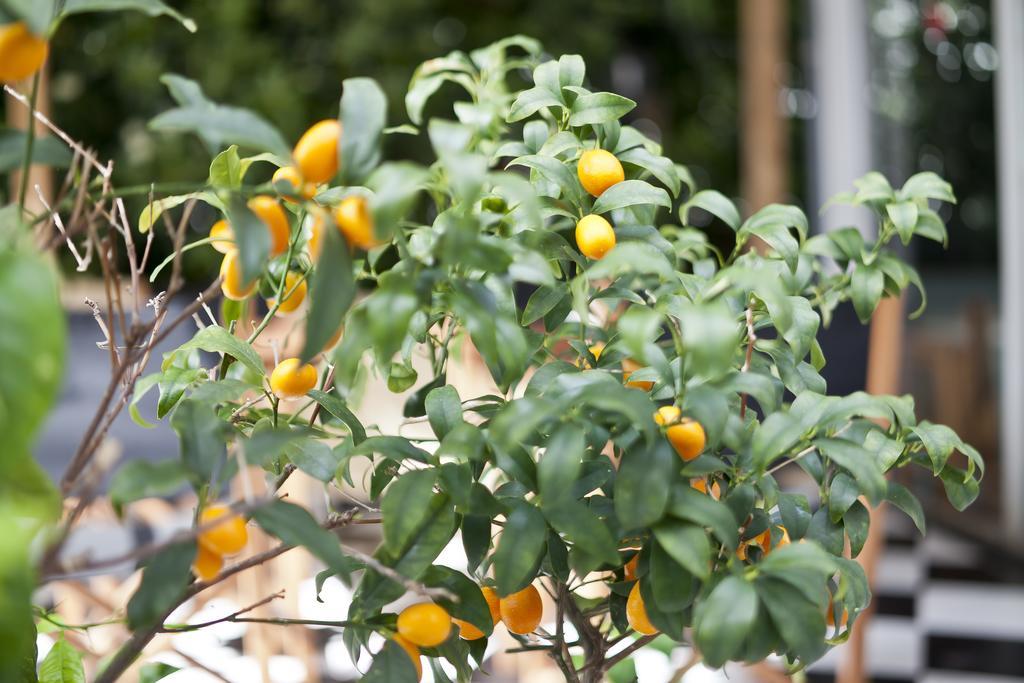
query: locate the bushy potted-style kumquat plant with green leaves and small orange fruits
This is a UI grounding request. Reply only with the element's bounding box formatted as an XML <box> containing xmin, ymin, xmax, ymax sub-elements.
<box><xmin>0</xmin><ymin>2</ymin><xmax>983</xmax><ymax>681</ymax></box>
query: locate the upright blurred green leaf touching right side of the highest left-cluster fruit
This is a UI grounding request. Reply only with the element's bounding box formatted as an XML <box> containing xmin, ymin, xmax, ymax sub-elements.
<box><xmin>339</xmin><ymin>78</ymin><xmax>387</xmax><ymax>185</ymax></box>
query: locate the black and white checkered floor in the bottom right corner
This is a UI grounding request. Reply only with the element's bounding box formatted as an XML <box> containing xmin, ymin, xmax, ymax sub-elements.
<box><xmin>808</xmin><ymin>512</ymin><xmax>1024</xmax><ymax>683</ymax></box>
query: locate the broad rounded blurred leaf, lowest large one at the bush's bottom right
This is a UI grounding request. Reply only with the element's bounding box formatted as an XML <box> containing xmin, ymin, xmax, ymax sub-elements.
<box><xmin>693</xmin><ymin>577</ymin><xmax>758</xmax><ymax>669</ymax></box>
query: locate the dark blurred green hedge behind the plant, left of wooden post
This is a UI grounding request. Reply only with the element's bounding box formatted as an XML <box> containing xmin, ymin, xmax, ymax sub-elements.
<box><xmin>44</xmin><ymin>0</ymin><xmax>736</xmax><ymax>197</ymax></box>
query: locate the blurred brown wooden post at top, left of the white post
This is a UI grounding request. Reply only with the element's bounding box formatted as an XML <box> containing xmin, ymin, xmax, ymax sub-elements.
<box><xmin>739</xmin><ymin>0</ymin><xmax>790</xmax><ymax>213</ymax></box>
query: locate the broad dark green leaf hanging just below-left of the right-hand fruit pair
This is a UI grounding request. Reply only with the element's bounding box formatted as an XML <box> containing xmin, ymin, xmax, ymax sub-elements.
<box><xmin>614</xmin><ymin>439</ymin><xmax>679</xmax><ymax>529</ymax></box>
